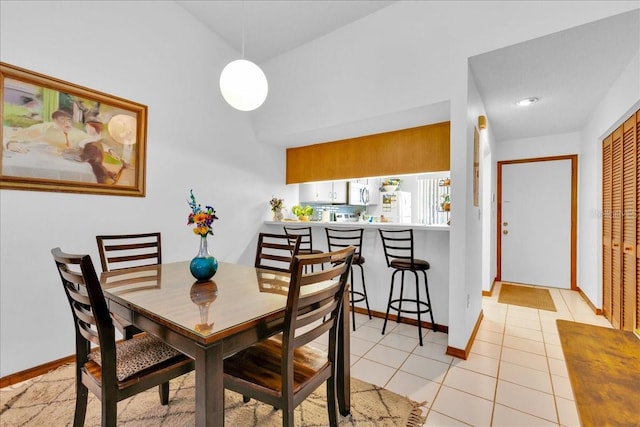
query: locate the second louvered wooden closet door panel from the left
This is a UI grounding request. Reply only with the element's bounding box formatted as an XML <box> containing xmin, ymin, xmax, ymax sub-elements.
<box><xmin>609</xmin><ymin>127</ymin><xmax>622</xmax><ymax>328</ymax></box>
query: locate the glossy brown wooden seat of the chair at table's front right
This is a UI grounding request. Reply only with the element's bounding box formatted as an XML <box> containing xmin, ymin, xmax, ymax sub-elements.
<box><xmin>224</xmin><ymin>336</ymin><xmax>329</xmax><ymax>393</ymax></box>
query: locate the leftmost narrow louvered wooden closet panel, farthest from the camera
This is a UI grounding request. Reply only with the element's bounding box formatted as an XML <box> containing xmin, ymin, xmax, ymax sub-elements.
<box><xmin>602</xmin><ymin>135</ymin><xmax>613</xmax><ymax>320</ymax></box>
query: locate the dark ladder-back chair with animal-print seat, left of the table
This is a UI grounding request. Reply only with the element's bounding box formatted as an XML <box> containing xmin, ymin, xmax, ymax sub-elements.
<box><xmin>51</xmin><ymin>248</ymin><xmax>194</xmax><ymax>427</ymax></box>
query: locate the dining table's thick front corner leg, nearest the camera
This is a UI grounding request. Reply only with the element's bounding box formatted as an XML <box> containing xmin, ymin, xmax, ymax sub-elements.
<box><xmin>195</xmin><ymin>344</ymin><xmax>224</xmax><ymax>427</ymax></box>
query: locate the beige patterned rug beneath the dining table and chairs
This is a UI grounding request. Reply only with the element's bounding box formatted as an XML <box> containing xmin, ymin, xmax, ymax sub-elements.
<box><xmin>0</xmin><ymin>365</ymin><xmax>425</xmax><ymax>427</ymax></box>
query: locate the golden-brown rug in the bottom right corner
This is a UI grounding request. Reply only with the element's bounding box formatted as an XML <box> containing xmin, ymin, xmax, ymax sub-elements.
<box><xmin>556</xmin><ymin>319</ymin><xmax>640</xmax><ymax>427</ymax></box>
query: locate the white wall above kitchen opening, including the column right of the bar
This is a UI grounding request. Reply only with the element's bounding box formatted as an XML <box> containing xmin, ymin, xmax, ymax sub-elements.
<box><xmin>255</xmin><ymin>1</ymin><xmax>638</xmax><ymax>348</ymax></box>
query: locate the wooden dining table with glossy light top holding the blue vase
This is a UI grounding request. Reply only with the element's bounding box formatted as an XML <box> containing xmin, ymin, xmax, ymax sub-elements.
<box><xmin>100</xmin><ymin>261</ymin><xmax>350</xmax><ymax>426</ymax></box>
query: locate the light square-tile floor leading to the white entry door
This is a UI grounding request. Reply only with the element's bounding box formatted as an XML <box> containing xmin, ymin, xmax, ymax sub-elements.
<box><xmin>336</xmin><ymin>284</ymin><xmax>611</xmax><ymax>427</ymax></box>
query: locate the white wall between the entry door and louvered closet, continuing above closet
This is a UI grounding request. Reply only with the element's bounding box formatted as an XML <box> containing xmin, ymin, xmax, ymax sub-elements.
<box><xmin>578</xmin><ymin>52</ymin><xmax>640</xmax><ymax>308</ymax></box>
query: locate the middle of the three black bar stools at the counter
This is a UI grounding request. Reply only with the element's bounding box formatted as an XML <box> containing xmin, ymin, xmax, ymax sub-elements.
<box><xmin>324</xmin><ymin>227</ymin><xmax>372</xmax><ymax>331</ymax></box>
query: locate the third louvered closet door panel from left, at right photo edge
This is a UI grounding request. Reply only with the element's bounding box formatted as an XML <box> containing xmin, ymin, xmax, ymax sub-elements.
<box><xmin>621</xmin><ymin>115</ymin><xmax>638</xmax><ymax>331</ymax></box>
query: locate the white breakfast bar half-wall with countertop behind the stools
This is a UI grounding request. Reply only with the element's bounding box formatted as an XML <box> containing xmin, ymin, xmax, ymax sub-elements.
<box><xmin>261</xmin><ymin>221</ymin><xmax>449</xmax><ymax>331</ymax></box>
